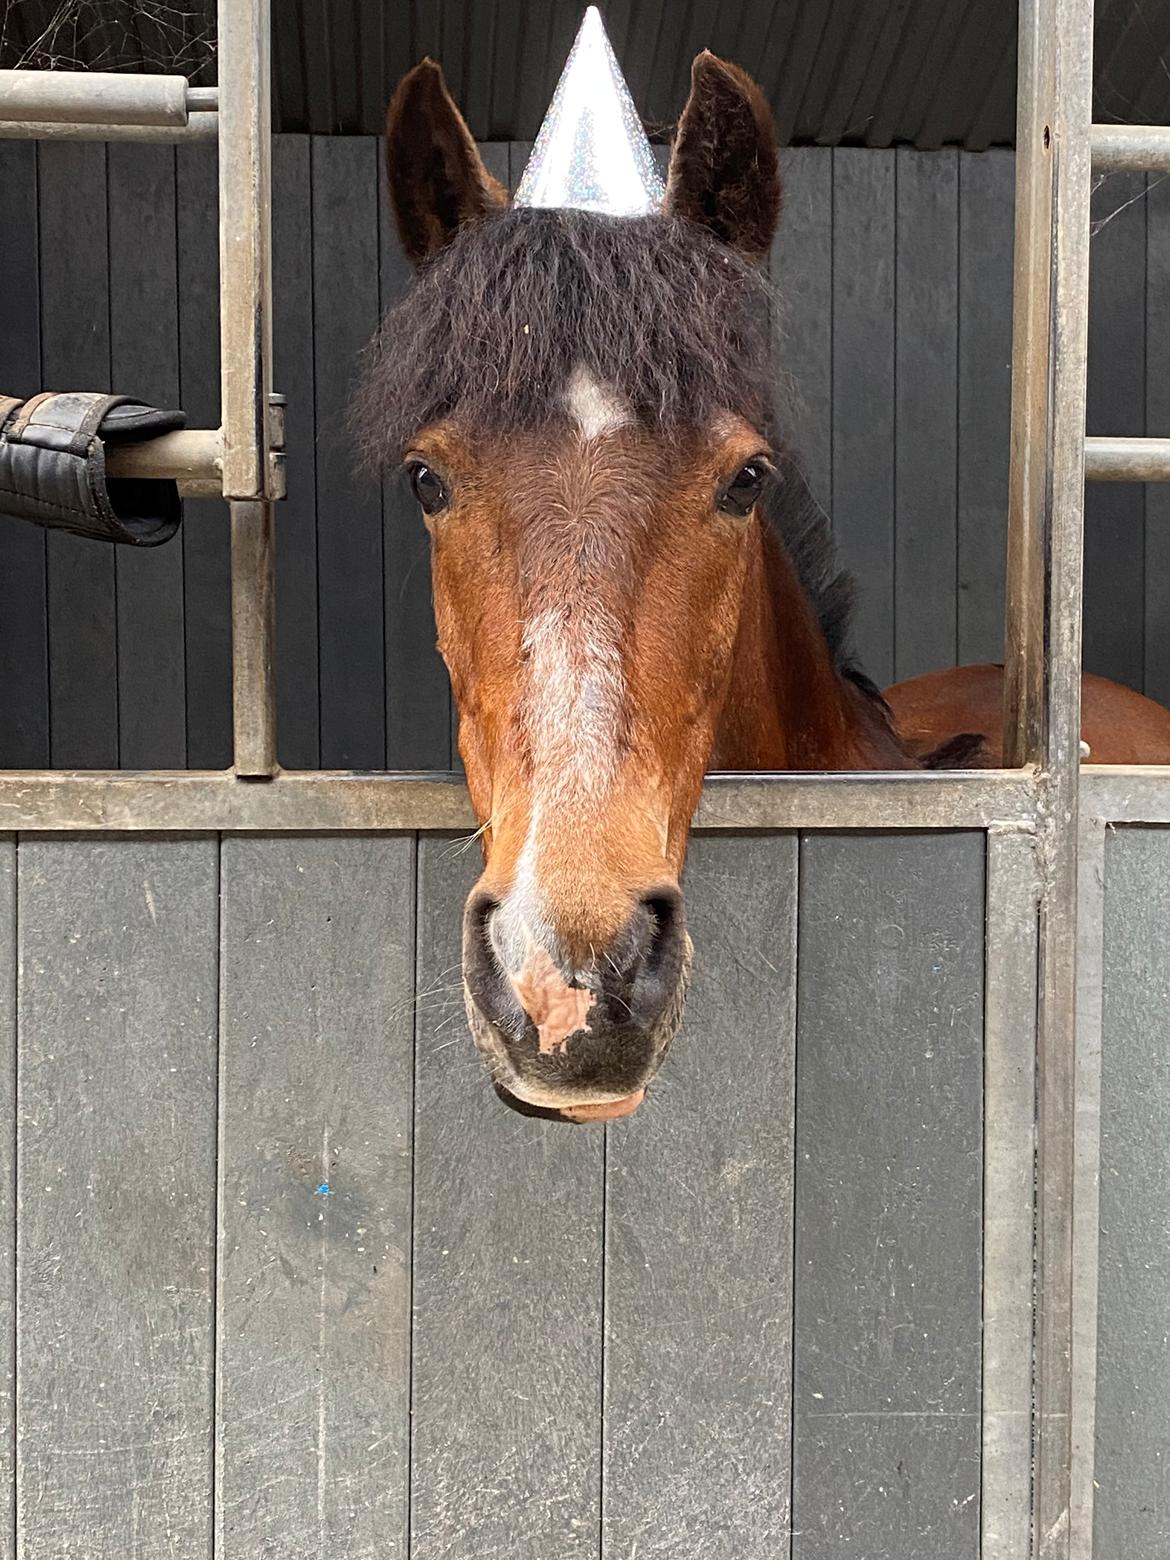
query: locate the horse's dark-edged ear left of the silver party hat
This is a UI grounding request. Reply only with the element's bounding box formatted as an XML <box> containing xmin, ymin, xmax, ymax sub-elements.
<box><xmin>385</xmin><ymin>59</ymin><xmax>509</xmax><ymax>265</ymax></box>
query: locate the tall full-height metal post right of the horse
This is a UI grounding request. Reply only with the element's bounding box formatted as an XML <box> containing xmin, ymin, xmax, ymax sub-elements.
<box><xmin>1005</xmin><ymin>0</ymin><xmax>1094</xmax><ymax>1560</ymax></box>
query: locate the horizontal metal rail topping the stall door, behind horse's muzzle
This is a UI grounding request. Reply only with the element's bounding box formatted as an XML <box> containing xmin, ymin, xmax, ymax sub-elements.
<box><xmin>0</xmin><ymin>769</ymin><xmax>1037</xmax><ymax>833</ymax></box>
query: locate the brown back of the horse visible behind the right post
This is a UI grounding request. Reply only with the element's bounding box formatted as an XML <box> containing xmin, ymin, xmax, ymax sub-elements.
<box><xmin>886</xmin><ymin>666</ymin><xmax>1170</xmax><ymax>764</ymax></box>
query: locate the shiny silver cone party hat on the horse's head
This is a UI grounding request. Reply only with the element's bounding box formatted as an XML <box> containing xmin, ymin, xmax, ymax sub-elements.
<box><xmin>515</xmin><ymin>5</ymin><xmax>666</xmax><ymax>217</ymax></box>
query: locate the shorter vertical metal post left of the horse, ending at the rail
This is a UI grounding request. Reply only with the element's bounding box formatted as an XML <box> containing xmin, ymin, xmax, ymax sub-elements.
<box><xmin>218</xmin><ymin>0</ymin><xmax>278</xmax><ymax>777</ymax></box>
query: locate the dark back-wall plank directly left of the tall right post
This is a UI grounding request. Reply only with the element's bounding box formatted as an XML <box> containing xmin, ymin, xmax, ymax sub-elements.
<box><xmin>956</xmin><ymin>151</ymin><xmax>1014</xmax><ymax>665</ymax></box>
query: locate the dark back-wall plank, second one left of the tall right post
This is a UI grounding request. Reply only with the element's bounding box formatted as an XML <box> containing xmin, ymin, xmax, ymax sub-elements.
<box><xmin>894</xmin><ymin>148</ymin><xmax>959</xmax><ymax>679</ymax></box>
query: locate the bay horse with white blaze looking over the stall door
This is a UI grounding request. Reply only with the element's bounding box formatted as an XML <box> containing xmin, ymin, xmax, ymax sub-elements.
<box><xmin>356</xmin><ymin>53</ymin><xmax>1170</xmax><ymax>1120</ymax></box>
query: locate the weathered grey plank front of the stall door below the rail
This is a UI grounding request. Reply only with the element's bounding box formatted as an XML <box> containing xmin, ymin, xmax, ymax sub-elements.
<box><xmin>0</xmin><ymin>835</ymin><xmax>983</xmax><ymax>1560</ymax></box>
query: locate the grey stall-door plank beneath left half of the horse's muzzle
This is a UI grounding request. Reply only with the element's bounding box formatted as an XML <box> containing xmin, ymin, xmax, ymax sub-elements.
<box><xmin>410</xmin><ymin>836</ymin><xmax>605</xmax><ymax>1560</ymax></box>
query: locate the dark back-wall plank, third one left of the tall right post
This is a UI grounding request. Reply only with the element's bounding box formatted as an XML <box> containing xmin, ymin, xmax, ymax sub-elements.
<box><xmin>833</xmin><ymin>147</ymin><xmax>897</xmax><ymax>683</ymax></box>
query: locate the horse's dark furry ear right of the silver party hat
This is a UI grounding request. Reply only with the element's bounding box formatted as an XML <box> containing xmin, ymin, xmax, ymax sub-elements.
<box><xmin>666</xmin><ymin>50</ymin><xmax>780</xmax><ymax>259</ymax></box>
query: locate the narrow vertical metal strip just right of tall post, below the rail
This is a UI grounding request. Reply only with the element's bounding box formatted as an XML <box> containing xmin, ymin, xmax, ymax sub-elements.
<box><xmin>1069</xmin><ymin>803</ymin><xmax>1106</xmax><ymax>1560</ymax></box>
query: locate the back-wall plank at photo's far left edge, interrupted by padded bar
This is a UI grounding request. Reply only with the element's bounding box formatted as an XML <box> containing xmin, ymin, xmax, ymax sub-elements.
<box><xmin>0</xmin><ymin>140</ymin><xmax>48</xmax><ymax>769</ymax></box>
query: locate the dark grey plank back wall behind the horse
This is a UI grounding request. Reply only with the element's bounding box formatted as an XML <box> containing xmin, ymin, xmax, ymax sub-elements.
<box><xmin>0</xmin><ymin>136</ymin><xmax>1170</xmax><ymax>768</ymax></box>
